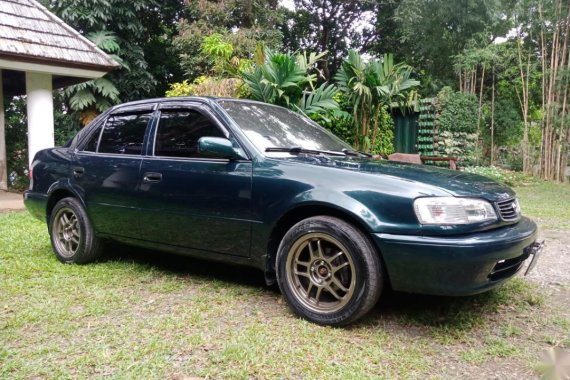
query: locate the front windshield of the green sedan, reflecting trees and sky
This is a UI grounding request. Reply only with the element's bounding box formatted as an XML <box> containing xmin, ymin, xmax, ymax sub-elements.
<box><xmin>218</xmin><ymin>100</ymin><xmax>352</xmax><ymax>156</ymax></box>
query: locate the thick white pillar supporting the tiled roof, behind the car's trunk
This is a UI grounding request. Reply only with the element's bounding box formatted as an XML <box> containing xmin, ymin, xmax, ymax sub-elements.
<box><xmin>26</xmin><ymin>71</ymin><xmax>55</xmax><ymax>165</ymax></box>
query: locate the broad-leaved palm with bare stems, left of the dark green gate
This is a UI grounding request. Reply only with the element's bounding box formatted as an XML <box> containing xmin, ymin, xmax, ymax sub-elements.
<box><xmin>335</xmin><ymin>50</ymin><xmax>420</xmax><ymax>151</ymax></box>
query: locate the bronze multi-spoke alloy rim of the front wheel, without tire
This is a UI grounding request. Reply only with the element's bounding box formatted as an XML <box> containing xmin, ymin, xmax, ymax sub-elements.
<box><xmin>286</xmin><ymin>233</ymin><xmax>356</xmax><ymax>313</ymax></box>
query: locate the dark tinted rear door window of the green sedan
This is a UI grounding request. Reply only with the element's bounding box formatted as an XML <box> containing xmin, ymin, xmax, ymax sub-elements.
<box><xmin>97</xmin><ymin>113</ymin><xmax>152</xmax><ymax>155</ymax></box>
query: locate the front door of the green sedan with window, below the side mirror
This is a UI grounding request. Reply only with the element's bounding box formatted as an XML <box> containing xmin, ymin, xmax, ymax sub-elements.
<box><xmin>136</xmin><ymin>103</ymin><xmax>252</xmax><ymax>256</ymax></box>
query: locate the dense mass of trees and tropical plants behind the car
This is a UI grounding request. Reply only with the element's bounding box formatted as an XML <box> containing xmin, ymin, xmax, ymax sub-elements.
<box><xmin>7</xmin><ymin>0</ymin><xmax>570</xmax><ymax>189</ymax></box>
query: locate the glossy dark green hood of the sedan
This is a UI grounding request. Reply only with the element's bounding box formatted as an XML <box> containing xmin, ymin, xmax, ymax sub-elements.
<box><xmin>286</xmin><ymin>156</ymin><xmax>515</xmax><ymax>202</ymax></box>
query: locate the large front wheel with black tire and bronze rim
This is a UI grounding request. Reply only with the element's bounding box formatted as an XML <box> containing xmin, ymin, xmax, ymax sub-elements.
<box><xmin>276</xmin><ymin>216</ymin><xmax>383</xmax><ymax>326</ymax></box>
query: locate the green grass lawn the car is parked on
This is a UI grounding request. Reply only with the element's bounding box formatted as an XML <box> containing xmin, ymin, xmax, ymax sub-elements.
<box><xmin>0</xmin><ymin>183</ymin><xmax>570</xmax><ymax>379</ymax></box>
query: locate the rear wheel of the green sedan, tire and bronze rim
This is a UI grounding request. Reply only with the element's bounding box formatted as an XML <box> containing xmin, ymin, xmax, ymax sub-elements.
<box><xmin>48</xmin><ymin>197</ymin><xmax>102</xmax><ymax>264</ymax></box>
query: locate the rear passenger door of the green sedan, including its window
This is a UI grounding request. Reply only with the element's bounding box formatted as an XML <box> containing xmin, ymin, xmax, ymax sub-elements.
<box><xmin>72</xmin><ymin>105</ymin><xmax>153</xmax><ymax>238</ymax></box>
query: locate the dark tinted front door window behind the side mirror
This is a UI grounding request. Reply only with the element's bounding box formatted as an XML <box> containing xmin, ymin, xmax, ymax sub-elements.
<box><xmin>154</xmin><ymin>110</ymin><xmax>226</xmax><ymax>158</ymax></box>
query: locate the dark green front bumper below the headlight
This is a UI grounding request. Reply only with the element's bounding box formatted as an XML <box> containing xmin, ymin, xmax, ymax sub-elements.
<box><xmin>372</xmin><ymin>217</ymin><xmax>537</xmax><ymax>296</ymax></box>
